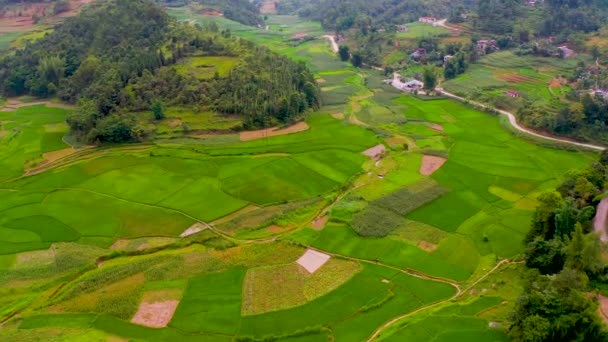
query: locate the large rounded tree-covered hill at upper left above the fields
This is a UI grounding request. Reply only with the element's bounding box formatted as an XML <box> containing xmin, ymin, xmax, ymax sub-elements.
<box><xmin>0</xmin><ymin>0</ymin><xmax>319</xmax><ymax>142</ymax></box>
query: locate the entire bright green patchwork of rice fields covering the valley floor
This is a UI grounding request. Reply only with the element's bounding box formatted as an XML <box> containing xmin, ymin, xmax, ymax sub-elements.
<box><xmin>0</xmin><ymin>9</ymin><xmax>594</xmax><ymax>342</ymax></box>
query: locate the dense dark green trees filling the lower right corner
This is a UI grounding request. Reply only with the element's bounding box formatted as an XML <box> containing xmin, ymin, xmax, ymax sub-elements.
<box><xmin>510</xmin><ymin>154</ymin><xmax>608</xmax><ymax>341</ymax></box>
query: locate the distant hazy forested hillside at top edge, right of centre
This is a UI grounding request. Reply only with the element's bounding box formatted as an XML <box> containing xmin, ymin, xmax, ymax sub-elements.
<box><xmin>277</xmin><ymin>0</ymin><xmax>463</xmax><ymax>31</ymax></box>
